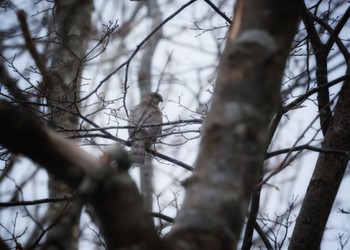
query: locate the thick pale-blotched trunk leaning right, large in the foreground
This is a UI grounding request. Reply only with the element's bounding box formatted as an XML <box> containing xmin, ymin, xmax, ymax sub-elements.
<box><xmin>172</xmin><ymin>0</ymin><xmax>299</xmax><ymax>249</ymax></box>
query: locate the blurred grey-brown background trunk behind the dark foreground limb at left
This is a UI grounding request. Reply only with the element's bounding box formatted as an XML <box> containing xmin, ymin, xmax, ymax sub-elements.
<box><xmin>44</xmin><ymin>0</ymin><xmax>93</xmax><ymax>250</ymax></box>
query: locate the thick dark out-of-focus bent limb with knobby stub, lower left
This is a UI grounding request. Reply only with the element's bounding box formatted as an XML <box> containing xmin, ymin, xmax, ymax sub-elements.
<box><xmin>0</xmin><ymin>101</ymin><xmax>162</xmax><ymax>249</ymax></box>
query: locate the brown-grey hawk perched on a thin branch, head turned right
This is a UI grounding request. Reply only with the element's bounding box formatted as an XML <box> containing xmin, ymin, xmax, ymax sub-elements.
<box><xmin>128</xmin><ymin>92</ymin><xmax>163</xmax><ymax>165</ymax></box>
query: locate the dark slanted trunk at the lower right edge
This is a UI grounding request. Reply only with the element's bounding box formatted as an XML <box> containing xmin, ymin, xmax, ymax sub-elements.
<box><xmin>289</xmin><ymin>65</ymin><xmax>350</xmax><ymax>250</ymax></box>
